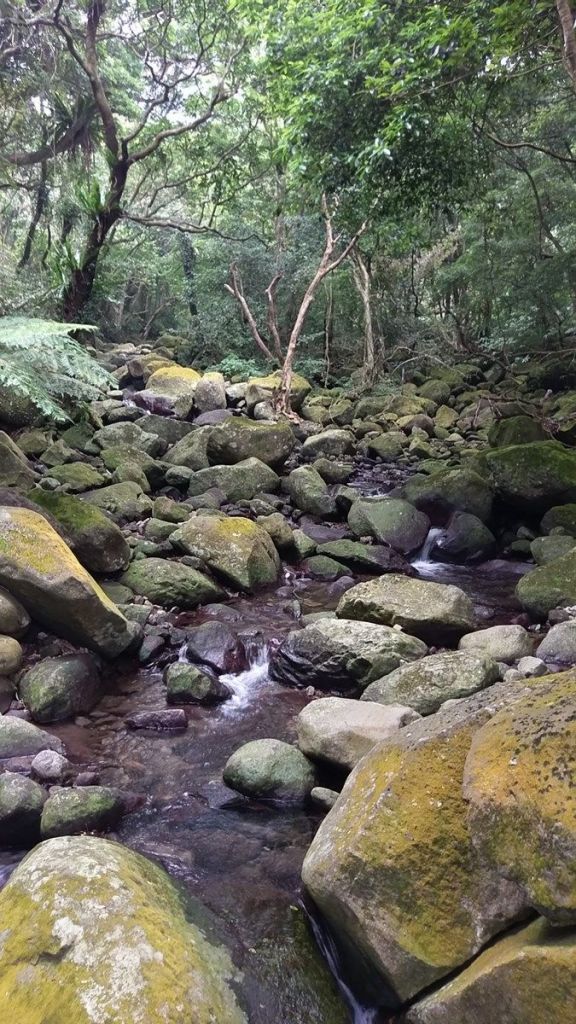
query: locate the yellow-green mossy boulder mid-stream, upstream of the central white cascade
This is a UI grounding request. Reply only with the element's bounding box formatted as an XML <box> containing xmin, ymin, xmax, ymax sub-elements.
<box><xmin>170</xmin><ymin>516</ymin><xmax>280</xmax><ymax>591</ymax></box>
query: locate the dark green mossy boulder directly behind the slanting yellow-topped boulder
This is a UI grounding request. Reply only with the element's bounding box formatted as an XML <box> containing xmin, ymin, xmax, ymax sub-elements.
<box><xmin>30</xmin><ymin>487</ymin><xmax>130</xmax><ymax>573</ymax></box>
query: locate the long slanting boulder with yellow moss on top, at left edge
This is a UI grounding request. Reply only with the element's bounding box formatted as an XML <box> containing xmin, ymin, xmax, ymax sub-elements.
<box><xmin>0</xmin><ymin>507</ymin><xmax>131</xmax><ymax>657</ymax></box>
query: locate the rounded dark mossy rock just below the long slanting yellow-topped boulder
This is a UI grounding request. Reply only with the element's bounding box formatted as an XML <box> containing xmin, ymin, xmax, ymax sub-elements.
<box><xmin>18</xmin><ymin>654</ymin><xmax>100</xmax><ymax>723</ymax></box>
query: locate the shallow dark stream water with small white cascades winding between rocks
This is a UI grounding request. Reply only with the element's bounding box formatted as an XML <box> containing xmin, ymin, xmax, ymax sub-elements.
<box><xmin>0</xmin><ymin>468</ymin><xmax>528</xmax><ymax>1024</ymax></box>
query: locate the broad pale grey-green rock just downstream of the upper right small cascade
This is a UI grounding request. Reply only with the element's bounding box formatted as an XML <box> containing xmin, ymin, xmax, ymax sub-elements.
<box><xmin>336</xmin><ymin>573</ymin><xmax>475</xmax><ymax>644</ymax></box>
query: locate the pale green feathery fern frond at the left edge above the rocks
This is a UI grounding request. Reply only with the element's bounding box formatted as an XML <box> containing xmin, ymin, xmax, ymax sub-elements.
<box><xmin>0</xmin><ymin>316</ymin><xmax>115</xmax><ymax>423</ymax></box>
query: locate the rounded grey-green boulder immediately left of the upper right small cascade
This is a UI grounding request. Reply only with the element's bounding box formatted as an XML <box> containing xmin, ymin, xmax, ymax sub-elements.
<box><xmin>348</xmin><ymin>498</ymin><xmax>429</xmax><ymax>554</ymax></box>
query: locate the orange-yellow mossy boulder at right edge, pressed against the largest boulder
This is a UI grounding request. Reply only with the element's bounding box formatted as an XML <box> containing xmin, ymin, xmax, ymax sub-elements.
<box><xmin>464</xmin><ymin>672</ymin><xmax>576</xmax><ymax>924</ymax></box>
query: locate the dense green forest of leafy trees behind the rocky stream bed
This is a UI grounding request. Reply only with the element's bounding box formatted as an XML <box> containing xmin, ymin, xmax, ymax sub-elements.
<box><xmin>0</xmin><ymin>0</ymin><xmax>576</xmax><ymax>383</ymax></box>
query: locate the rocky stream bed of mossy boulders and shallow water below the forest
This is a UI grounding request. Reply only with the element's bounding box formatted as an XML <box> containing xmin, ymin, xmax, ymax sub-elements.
<box><xmin>0</xmin><ymin>349</ymin><xmax>576</xmax><ymax>1024</ymax></box>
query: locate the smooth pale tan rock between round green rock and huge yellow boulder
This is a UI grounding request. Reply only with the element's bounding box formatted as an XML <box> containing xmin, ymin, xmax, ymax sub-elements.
<box><xmin>296</xmin><ymin>697</ymin><xmax>419</xmax><ymax>770</ymax></box>
